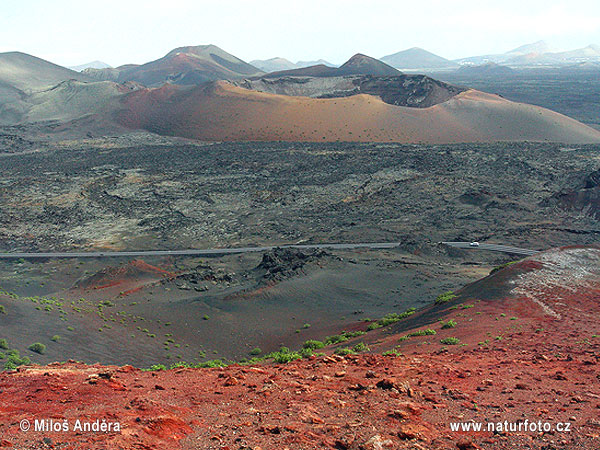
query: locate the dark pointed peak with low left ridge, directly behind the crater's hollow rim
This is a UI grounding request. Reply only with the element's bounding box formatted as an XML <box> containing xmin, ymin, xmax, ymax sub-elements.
<box><xmin>265</xmin><ymin>53</ymin><xmax>402</xmax><ymax>78</ymax></box>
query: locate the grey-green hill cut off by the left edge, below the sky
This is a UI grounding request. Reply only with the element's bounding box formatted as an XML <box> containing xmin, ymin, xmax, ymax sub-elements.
<box><xmin>0</xmin><ymin>52</ymin><xmax>90</xmax><ymax>92</ymax></box>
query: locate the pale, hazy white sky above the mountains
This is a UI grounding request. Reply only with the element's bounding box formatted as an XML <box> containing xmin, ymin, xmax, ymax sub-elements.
<box><xmin>0</xmin><ymin>0</ymin><xmax>600</xmax><ymax>66</ymax></box>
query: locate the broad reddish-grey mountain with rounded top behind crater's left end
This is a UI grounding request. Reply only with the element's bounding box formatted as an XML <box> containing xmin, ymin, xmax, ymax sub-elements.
<box><xmin>112</xmin><ymin>45</ymin><xmax>262</xmax><ymax>86</ymax></box>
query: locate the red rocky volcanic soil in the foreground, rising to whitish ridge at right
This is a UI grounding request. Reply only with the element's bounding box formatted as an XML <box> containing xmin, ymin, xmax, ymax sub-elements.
<box><xmin>0</xmin><ymin>248</ymin><xmax>600</xmax><ymax>450</ymax></box>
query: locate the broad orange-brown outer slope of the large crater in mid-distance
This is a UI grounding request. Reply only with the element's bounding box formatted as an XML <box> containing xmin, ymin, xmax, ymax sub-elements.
<box><xmin>112</xmin><ymin>82</ymin><xmax>600</xmax><ymax>143</ymax></box>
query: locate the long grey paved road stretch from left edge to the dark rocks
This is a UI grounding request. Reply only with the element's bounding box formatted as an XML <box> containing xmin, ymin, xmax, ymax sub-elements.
<box><xmin>0</xmin><ymin>242</ymin><xmax>406</xmax><ymax>259</ymax></box>
